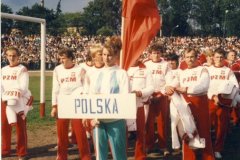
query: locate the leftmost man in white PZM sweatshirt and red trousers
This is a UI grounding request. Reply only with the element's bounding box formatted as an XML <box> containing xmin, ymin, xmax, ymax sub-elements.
<box><xmin>1</xmin><ymin>47</ymin><xmax>32</xmax><ymax>160</ymax></box>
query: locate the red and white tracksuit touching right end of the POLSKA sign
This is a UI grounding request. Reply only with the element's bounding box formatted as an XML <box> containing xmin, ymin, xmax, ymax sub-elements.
<box><xmin>127</xmin><ymin>66</ymin><xmax>154</xmax><ymax>159</ymax></box>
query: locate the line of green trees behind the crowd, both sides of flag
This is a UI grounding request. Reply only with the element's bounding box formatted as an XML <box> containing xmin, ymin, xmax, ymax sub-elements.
<box><xmin>1</xmin><ymin>0</ymin><xmax>240</xmax><ymax>36</ymax></box>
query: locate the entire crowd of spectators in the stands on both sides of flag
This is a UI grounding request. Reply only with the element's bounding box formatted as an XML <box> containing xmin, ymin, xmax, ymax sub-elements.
<box><xmin>1</xmin><ymin>34</ymin><xmax>240</xmax><ymax>70</ymax></box>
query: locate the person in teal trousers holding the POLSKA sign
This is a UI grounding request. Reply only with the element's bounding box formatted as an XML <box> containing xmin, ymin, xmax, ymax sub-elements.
<box><xmin>84</xmin><ymin>36</ymin><xmax>129</xmax><ymax>160</ymax></box>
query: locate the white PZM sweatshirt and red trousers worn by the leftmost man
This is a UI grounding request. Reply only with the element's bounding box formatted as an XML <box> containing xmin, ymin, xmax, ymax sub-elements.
<box><xmin>1</xmin><ymin>64</ymin><xmax>29</xmax><ymax>156</ymax></box>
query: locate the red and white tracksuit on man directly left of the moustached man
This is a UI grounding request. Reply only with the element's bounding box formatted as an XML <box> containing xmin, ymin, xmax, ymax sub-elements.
<box><xmin>145</xmin><ymin>59</ymin><xmax>171</xmax><ymax>149</ymax></box>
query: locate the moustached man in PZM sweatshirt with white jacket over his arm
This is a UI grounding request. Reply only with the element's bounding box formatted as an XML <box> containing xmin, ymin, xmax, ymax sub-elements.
<box><xmin>166</xmin><ymin>48</ymin><xmax>214</xmax><ymax>160</ymax></box>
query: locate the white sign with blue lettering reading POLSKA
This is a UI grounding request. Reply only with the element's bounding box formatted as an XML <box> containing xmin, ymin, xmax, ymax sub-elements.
<box><xmin>58</xmin><ymin>93</ymin><xmax>137</xmax><ymax>119</ymax></box>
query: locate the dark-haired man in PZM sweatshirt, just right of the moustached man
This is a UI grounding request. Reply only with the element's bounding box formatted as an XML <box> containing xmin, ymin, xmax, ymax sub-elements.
<box><xmin>208</xmin><ymin>48</ymin><xmax>239</xmax><ymax>158</ymax></box>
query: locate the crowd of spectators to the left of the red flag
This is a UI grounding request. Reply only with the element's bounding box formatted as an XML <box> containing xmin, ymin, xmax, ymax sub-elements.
<box><xmin>1</xmin><ymin>34</ymin><xmax>104</xmax><ymax>70</ymax></box>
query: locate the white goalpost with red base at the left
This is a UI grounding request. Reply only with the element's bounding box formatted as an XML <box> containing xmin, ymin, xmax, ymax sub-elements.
<box><xmin>1</xmin><ymin>12</ymin><xmax>46</xmax><ymax>117</ymax></box>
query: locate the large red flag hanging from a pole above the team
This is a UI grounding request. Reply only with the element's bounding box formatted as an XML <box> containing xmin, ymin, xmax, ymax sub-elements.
<box><xmin>122</xmin><ymin>0</ymin><xmax>161</xmax><ymax>69</ymax></box>
